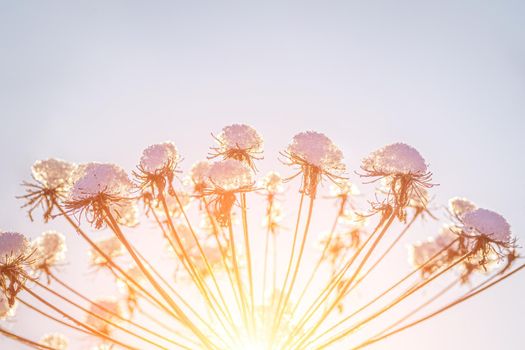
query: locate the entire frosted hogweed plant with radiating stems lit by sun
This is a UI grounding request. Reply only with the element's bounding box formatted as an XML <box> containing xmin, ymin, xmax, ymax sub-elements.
<box><xmin>0</xmin><ymin>124</ymin><xmax>524</xmax><ymax>350</ymax></box>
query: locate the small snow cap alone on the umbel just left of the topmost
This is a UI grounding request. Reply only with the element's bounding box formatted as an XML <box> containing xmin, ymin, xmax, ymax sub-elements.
<box><xmin>140</xmin><ymin>142</ymin><xmax>180</xmax><ymax>174</ymax></box>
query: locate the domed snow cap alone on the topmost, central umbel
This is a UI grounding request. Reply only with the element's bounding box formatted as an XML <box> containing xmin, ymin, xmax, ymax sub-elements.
<box><xmin>217</xmin><ymin>124</ymin><xmax>263</xmax><ymax>153</ymax></box>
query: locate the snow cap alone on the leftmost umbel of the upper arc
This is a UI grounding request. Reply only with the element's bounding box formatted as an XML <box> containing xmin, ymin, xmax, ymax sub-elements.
<box><xmin>31</xmin><ymin>158</ymin><xmax>77</xmax><ymax>191</ymax></box>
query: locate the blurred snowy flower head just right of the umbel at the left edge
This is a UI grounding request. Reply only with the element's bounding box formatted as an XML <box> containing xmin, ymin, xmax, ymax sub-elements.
<box><xmin>32</xmin><ymin>231</ymin><xmax>67</xmax><ymax>269</ymax></box>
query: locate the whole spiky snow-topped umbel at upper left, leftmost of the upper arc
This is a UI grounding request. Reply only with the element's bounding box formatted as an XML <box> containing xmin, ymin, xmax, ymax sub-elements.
<box><xmin>20</xmin><ymin>158</ymin><xmax>78</xmax><ymax>222</ymax></box>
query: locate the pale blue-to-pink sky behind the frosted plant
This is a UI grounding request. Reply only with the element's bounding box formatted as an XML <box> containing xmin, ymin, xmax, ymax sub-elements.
<box><xmin>0</xmin><ymin>0</ymin><xmax>525</xmax><ymax>350</ymax></box>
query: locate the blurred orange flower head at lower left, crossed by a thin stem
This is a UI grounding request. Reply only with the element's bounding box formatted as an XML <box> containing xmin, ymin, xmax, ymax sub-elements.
<box><xmin>86</xmin><ymin>298</ymin><xmax>124</xmax><ymax>335</ymax></box>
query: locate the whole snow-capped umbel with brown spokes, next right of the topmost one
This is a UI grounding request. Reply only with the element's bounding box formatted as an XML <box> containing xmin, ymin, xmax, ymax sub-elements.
<box><xmin>282</xmin><ymin>131</ymin><xmax>346</xmax><ymax>198</ymax></box>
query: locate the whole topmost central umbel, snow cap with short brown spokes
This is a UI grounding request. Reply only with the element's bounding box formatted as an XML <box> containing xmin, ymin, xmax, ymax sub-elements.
<box><xmin>210</xmin><ymin>124</ymin><xmax>263</xmax><ymax>169</ymax></box>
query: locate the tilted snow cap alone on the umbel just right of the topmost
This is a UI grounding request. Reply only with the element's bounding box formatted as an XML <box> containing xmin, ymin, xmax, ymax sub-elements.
<box><xmin>287</xmin><ymin>131</ymin><xmax>345</xmax><ymax>173</ymax></box>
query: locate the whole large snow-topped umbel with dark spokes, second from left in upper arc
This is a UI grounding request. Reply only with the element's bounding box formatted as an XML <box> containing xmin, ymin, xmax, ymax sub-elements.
<box><xmin>66</xmin><ymin>163</ymin><xmax>133</xmax><ymax>229</ymax></box>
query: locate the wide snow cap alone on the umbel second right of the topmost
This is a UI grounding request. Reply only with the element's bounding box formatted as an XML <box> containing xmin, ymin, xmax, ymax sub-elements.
<box><xmin>362</xmin><ymin>143</ymin><xmax>428</xmax><ymax>176</ymax></box>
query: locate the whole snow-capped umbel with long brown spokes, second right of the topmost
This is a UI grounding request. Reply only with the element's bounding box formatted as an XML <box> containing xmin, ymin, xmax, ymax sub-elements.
<box><xmin>361</xmin><ymin>143</ymin><xmax>432</xmax><ymax>221</ymax></box>
